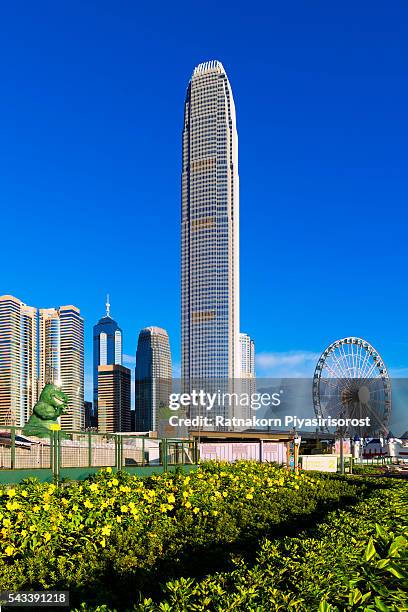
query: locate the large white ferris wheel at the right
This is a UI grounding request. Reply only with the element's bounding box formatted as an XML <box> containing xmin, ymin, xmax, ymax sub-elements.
<box><xmin>313</xmin><ymin>337</ymin><xmax>391</xmax><ymax>438</ymax></box>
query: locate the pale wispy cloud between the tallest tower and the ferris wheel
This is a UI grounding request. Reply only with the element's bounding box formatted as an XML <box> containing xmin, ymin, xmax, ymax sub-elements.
<box><xmin>256</xmin><ymin>351</ymin><xmax>320</xmax><ymax>378</ymax></box>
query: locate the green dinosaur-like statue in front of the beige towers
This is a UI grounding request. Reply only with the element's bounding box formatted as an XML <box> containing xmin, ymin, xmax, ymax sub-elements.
<box><xmin>22</xmin><ymin>384</ymin><xmax>68</xmax><ymax>438</ymax></box>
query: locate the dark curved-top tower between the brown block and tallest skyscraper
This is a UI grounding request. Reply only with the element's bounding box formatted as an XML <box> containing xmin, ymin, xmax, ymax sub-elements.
<box><xmin>135</xmin><ymin>327</ymin><xmax>172</xmax><ymax>433</ymax></box>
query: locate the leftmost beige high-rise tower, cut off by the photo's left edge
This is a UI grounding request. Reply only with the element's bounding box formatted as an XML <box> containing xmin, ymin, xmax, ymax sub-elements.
<box><xmin>0</xmin><ymin>295</ymin><xmax>38</xmax><ymax>427</ymax></box>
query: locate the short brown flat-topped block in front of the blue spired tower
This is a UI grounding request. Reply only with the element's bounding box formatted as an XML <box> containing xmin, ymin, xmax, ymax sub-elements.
<box><xmin>98</xmin><ymin>364</ymin><xmax>131</xmax><ymax>433</ymax></box>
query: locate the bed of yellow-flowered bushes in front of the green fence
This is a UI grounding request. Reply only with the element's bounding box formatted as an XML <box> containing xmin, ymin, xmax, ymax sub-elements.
<box><xmin>0</xmin><ymin>462</ymin><xmax>404</xmax><ymax>610</ymax></box>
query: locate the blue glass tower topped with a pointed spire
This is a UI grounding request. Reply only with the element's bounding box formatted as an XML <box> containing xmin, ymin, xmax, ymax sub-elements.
<box><xmin>93</xmin><ymin>295</ymin><xmax>122</xmax><ymax>415</ymax></box>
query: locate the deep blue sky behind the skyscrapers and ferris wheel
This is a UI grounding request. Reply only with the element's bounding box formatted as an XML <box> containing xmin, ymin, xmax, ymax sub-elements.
<box><xmin>0</xmin><ymin>0</ymin><xmax>408</xmax><ymax>424</ymax></box>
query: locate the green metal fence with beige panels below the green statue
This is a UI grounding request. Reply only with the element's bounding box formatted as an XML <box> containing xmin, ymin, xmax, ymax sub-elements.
<box><xmin>0</xmin><ymin>427</ymin><xmax>198</xmax><ymax>482</ymax></box>
